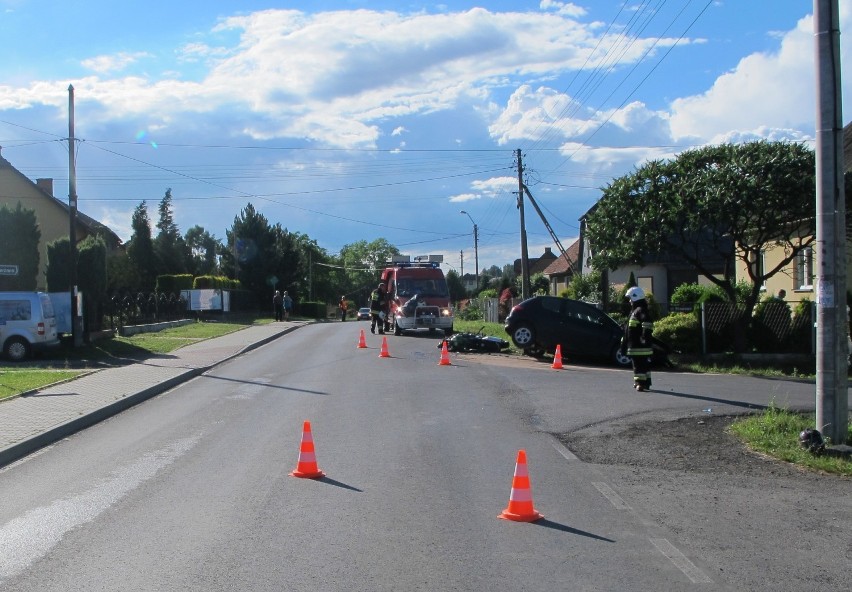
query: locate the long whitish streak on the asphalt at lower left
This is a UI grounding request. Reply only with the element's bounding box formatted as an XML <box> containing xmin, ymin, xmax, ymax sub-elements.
<box><xmin>0</xmin><ymin>436</ymin><xmax>200</xmax><ymax>578</ymax></box>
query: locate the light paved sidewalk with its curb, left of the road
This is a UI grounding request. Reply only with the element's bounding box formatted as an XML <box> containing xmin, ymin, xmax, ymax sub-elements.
<box><xmin>0</xmin><ymin>321</ymin><xmax>307</xmax><ymax>467</ymax></box>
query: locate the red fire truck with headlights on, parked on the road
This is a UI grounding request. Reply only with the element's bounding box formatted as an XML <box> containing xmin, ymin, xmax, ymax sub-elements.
<box><xmin>382</xmin><ymin>255</ymin><xmax>453</xmax><ymax>335</ymax></box>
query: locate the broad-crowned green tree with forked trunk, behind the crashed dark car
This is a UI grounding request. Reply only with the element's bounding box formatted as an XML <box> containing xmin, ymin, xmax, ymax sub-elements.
<box><xmin>586</xmin><ymin>142</ymin><xmax>815</xmax><ymax>349</ymax></box>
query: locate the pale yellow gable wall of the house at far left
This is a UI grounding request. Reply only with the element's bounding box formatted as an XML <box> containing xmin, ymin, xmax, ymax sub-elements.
<box><xmin>0</xmin><ymin>168</ymin><xmax>93</xmax><ymax>290</ymax></box>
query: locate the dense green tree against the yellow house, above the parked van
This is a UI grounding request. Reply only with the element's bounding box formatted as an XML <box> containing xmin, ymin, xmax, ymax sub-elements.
<box><xmin>0</xmin><ymin>202</ymin><xmax>41</xmax><ymax>291</ymax></box>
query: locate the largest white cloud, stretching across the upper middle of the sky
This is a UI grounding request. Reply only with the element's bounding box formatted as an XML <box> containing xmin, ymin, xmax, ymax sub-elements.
<box><xmin>0</xmin><ymin>6</ymin><xmax>674</xmax><ymax>147</ymax></box>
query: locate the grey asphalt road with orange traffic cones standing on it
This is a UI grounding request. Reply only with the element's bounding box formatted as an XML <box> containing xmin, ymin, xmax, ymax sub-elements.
<box><xmin>0</xmin><ymin>322</ymin><xmax>848</xmax><ymax>591</ymax></box>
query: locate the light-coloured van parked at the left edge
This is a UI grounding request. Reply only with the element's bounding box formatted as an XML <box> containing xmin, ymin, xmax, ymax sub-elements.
<box><xmin>0</xmin><ymin>292</ymin><xmax>59</xmax><ymax>362</ymax></box>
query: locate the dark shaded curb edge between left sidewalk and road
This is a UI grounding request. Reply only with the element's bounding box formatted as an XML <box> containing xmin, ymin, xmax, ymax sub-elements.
<box><xmin>0</xmin><ymin>325</ymin><xmax>305</xmax><ymax>467</ymax></box>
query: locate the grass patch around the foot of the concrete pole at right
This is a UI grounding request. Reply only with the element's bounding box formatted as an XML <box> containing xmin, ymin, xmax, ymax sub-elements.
<box><xmin>729</xmin><ymin>405</ymin><xmax>852</xmax><ymax>477</ymax></box>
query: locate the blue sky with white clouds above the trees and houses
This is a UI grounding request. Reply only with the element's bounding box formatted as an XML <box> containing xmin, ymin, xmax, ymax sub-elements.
<box><xmin>0</xmin><ymin>0</ymin><xmax>852</xmax><ymax>272</ymax></box>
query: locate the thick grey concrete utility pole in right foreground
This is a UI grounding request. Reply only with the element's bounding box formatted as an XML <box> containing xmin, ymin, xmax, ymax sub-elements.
<box><xmin>814</xmin><ymin>0</ymin><xmax>849</xmax><ymax>444</ymax></box>
